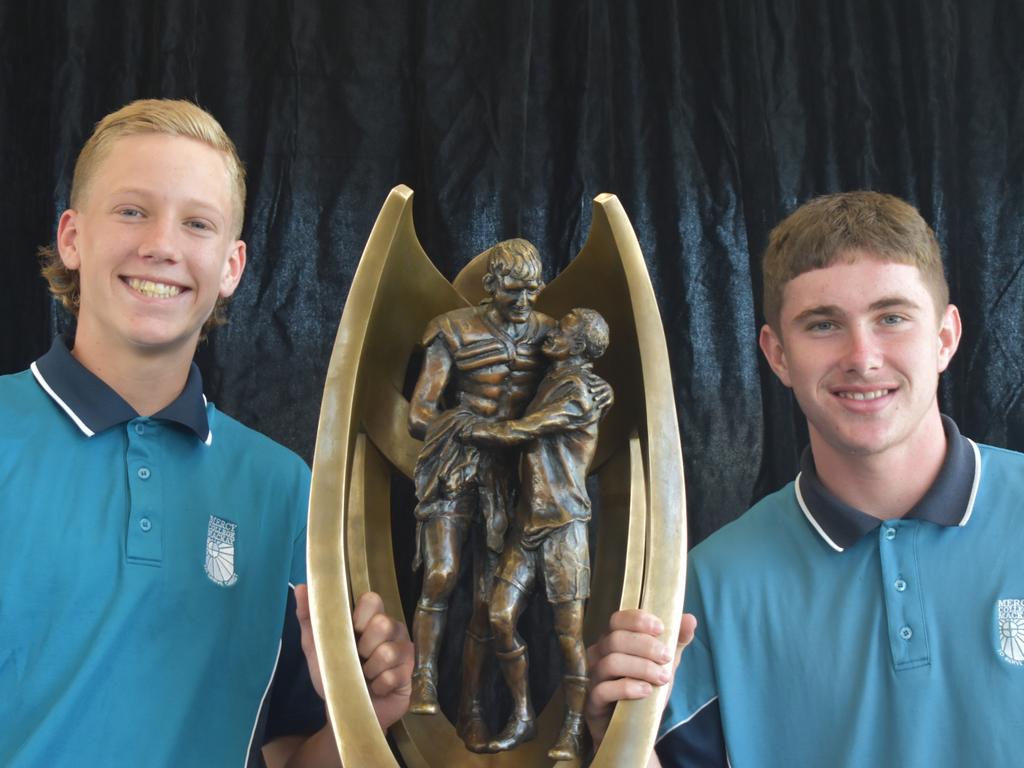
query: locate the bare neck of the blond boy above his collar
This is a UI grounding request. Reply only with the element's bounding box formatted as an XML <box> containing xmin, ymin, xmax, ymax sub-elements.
<box><xmin>72</xmin><ymin>328</ymin><xmax>196</xmax><ymax>416</ymax></box>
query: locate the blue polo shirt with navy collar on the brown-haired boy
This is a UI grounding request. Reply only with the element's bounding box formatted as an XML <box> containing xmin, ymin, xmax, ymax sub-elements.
<box><xmin>657</xmin><ymin>418</ymin><xmax>1024</xmax><ymax>768</ymax></box>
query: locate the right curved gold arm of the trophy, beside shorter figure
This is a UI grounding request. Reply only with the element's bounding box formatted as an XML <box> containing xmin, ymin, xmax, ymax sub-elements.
<box><xmin>577</xmin><ymin>195</ymin><xmax>686</xmax><ymax>768</ymax></box>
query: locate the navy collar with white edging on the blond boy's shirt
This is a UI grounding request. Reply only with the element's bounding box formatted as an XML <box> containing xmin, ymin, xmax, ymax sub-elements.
<box><xmin>32</xmin><ymin>336</ymin><xmax>213</xmax><ymax>445</ymax></box>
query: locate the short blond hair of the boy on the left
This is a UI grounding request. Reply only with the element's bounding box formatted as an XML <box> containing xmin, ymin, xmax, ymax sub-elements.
<box><xmin>39</xmin><ymin>98</ymin><xmax>246</xmax><ymax>334</ymax></box>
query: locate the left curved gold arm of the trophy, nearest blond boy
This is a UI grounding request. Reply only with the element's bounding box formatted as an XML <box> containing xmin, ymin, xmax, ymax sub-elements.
<box><xmin>307</xmin><ymin>186</ymin><xmax>465</xmax><ymax>766</ymax></box>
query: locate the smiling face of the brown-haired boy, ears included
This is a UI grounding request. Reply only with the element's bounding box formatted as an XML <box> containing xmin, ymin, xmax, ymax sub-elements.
<box><xmin>761</xmin><ymin>252</ymin><xmax>961</xmax><ymax>460</ymax></box>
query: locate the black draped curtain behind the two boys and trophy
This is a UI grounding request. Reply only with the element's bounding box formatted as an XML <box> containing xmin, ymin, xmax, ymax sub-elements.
<box><xmin>0</xmin><ymin>0</ymin><xmax>1024</xmax><ymax>543</ymax></box>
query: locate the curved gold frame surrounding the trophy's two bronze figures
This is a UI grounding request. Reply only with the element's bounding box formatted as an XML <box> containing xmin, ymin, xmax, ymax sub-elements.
<box><xmin>308</xmin><ymin>186</ymin><xmax>686</xmax><ymax>768</ymax></box>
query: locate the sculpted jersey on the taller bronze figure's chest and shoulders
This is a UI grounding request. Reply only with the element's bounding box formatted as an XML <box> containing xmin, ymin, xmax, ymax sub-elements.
<box><xmin>423</xmin><ymin>305</ymin><xmax>555</xmax><ymax>419</ymax></box>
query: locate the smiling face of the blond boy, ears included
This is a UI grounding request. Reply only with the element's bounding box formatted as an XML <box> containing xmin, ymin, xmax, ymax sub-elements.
<box><xmin>57</xmin><ymin>134</ymin><xmax>246</xmax><ymax>352</ymax></box>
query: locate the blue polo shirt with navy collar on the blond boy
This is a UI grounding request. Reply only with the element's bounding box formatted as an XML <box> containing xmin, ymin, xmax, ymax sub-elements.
<box><xmin>0</xmin><ymin>339</ymin><xmax>319</xmax><ymax>767</ymax></box>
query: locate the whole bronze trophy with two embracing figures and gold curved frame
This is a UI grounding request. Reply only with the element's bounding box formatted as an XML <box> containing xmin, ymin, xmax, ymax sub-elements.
<box><xmin>308</xmin><ymin>186</ymin><xmax>686</xmax><ymax>768</ymax></box>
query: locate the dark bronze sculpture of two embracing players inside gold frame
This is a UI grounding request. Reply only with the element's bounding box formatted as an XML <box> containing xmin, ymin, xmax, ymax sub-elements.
<box><xmin>409</xmin><ymin>240</ymin><xmax>611</xmax><ymax>760</ymax></box>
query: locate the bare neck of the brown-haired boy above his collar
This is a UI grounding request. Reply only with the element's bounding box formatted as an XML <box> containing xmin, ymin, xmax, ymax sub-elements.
<box><xmin>810</xmin><ymin>404</ymin><xmax>946</xmax><ymax>520</ymax></box>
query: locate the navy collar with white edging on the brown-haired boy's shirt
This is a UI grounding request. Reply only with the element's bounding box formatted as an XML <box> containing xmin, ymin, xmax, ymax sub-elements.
<box><xmin>796</xmin><ymin>416</ymin><xmax>981</xmax><ymax>552</ymax></box>
